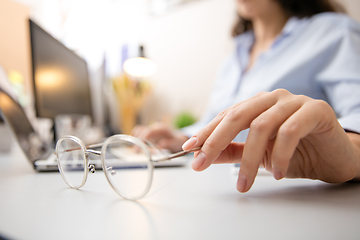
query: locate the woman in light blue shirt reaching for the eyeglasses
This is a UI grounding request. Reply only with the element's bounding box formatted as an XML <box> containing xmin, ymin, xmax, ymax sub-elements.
<box><xmin>135</xmin><ymin>0</ymin><xmax>360</xmax><ymax>192</ymax></box>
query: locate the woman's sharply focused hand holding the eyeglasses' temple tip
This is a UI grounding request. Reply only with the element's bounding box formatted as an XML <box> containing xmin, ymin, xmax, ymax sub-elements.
<box><xmin>183</xmin><ymin>89</ymin><xmax>360</xmax><ymax>192</ymax></box>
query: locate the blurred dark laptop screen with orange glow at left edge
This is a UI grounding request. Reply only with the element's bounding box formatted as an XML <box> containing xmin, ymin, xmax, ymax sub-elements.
<box><xmin>0</xmin><ymin>89</ymin><xmax>47</xmax><ymax>163</ymax></box>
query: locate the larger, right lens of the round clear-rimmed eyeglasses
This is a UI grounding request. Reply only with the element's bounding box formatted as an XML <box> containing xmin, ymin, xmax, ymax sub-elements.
<box><xmin>102</xmin><ymin>135</ymin><xmax>152</xmax><ymax>200</ymax></box>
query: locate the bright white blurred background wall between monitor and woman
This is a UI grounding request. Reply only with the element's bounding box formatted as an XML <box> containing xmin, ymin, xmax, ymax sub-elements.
<box><xmin>12</xmin><ymin>0</ymin><xmax>236</xmax><ymax>127</ymax></box>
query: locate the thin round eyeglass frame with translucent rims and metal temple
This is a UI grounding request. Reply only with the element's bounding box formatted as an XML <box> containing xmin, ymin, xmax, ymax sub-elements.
<box><xmin>54</xmin><ymin>134</ymin><xmax>201</xmax><ymax>200</ymax></box>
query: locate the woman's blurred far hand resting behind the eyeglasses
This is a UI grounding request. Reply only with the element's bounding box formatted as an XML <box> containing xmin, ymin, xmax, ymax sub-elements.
<box><xmin>131</xmin><ymin>123</ymin><xmax>189</xmax><ymax>152</ymax></box>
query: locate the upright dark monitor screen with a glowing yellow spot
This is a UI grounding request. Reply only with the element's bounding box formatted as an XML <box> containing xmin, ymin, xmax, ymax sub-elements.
<box><xmin>30</xmin><ymin>20</ymin><xmax>92</xmax><ymax>119</ymax></box>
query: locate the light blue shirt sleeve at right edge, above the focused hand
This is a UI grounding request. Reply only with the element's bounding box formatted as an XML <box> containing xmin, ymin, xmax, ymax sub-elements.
<box><xmin>318</xmin><ymin>16</ymin><xmax>360</xmax><ymax>133</ymax></box>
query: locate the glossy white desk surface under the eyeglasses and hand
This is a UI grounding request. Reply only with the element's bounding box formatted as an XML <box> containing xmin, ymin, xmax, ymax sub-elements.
<box><xmin>0</xmin><ymin>142</ymin><xmax>360</xmax><ymax>240</ymax></box>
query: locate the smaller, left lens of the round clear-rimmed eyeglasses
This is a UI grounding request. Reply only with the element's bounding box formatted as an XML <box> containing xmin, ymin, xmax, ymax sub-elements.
<box><xmin>56</xmin><ymin>138</ymin><xmax>86</xmax><ymax>188</ymax></box>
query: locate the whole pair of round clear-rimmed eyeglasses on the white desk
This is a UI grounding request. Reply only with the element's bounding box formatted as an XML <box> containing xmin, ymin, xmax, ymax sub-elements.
<box><xmin>55</xmin><ymin>134</ymin><xmax>200</xmax><ymax>200</ymax></box>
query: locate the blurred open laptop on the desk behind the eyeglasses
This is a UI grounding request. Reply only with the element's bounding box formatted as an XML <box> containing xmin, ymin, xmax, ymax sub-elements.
<box><xmin>0</xmin><ymin>88</ymin><xmax>189</xmax><ymax>172</ymax></box>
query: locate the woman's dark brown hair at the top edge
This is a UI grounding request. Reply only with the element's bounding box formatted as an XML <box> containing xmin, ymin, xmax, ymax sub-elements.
<box><xmin>232</xmin><ymin>0</ymin><xmax>346</xmax><ymax>37</ymax></box>
